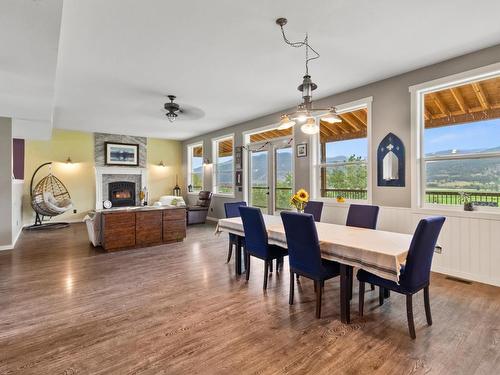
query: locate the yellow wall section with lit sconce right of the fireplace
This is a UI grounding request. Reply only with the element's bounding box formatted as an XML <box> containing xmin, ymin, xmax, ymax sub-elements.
<box><xmin>148</xmin><ymin>138</ymin><xmax>185</xmax><ymax>203</ymax></box>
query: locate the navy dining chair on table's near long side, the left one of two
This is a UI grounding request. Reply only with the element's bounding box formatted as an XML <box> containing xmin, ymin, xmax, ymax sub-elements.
<box><xmin>239</xmin><ymin>206</ymin><xmax>288</xmax><ymax>290</ymax></box>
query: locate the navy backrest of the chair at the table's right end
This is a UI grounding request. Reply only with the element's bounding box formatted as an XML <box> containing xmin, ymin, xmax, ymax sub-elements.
<box><xmin>400</xmin><ymin>216</ymin><xmax>445</xmax><ymax>291</ymax></box>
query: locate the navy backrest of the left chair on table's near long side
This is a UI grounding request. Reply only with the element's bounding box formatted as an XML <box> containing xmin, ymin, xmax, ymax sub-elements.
<box><xmin>238</xmin><ymin>206</ymin><xmax>268</xmax><ymax>259</ymax></box>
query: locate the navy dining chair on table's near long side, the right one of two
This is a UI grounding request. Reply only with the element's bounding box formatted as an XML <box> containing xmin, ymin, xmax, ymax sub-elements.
<box><xmin>281</xmin><ymin>211</ymin><xmax>340</xmax><ymax>319</ymax></box>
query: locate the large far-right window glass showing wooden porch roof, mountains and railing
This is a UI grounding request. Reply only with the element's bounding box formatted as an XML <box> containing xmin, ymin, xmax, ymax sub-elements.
<box><xmin>420</xmin><ymin>76</ymin><xmax>500</xmax><ymax>207</ymax></box>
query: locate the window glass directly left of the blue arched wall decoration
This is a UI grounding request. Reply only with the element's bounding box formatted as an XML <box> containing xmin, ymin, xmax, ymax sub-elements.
<box><xmin>317</xmin><ymin>103</ymin><xmax>369</xmax><ymax>201</ymax></box>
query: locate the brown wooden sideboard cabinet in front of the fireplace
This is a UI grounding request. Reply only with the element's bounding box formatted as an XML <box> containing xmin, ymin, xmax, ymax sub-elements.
<box><xmin>101</xmin><ymin>207</ymin><xmax>186</xmax><ymax>251</ymax></box>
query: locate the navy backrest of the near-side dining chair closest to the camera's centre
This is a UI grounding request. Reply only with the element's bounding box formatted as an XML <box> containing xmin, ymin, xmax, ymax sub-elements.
<box><xmin>281</xmin><ymin>211</ymin><xmax>322</xmax><ymax>279</ymax></box>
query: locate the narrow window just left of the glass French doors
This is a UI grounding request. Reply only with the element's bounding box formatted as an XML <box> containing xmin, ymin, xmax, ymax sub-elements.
<box><xmin>213</xmin><ymin>135</ymin><xmax>234</xmax><ymax>195</ymax></box>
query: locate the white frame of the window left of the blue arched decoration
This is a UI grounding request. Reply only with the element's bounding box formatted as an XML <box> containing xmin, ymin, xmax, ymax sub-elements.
<box><xmin>310</xmin><ymin>96</ymin><xmax>373</xmax><ymax>206</ymax></box>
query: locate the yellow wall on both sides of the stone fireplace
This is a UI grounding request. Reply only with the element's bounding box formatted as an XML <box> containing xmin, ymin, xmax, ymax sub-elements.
<box><xmin>23</xmin><ymin>129</ymin><xmax>184</xmax><ymax>224</ymax></box>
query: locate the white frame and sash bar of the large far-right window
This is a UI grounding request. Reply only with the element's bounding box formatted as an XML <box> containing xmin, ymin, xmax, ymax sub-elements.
<box><xmin>409</xmin><ymin>63</ymin><xmax>500</xmax><ymax>215</ymax></box>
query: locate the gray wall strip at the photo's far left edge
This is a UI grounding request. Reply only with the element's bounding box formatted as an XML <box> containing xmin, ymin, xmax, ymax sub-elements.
<box><xmin>0</xmin><ymin>117</ymin><xmax>12</xmax><ymax>247</ymax></box>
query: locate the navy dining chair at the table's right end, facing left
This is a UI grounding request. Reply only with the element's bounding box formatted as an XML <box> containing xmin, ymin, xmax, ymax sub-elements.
<box><xmin>357</xmin><ymin>216</ymin><xmax>445</xmax><ymax>339</ymax></box>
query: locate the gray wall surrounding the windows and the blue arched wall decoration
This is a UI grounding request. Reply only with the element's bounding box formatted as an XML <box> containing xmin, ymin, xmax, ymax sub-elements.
<box><xmin>183</xmin><ymin>45</ymin><xmax>500</xmax><ymax>217</ymax></box>
